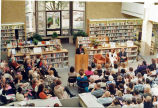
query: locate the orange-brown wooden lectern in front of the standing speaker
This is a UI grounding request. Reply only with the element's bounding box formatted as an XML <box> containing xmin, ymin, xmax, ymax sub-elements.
<box><xmin>75</xmin><ymin>54</ymin><xmax>88</xmax><ymax>72</ymax></box>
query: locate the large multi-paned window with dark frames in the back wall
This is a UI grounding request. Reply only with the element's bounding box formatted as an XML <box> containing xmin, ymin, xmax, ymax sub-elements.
<box><xmin>35</xmin><ymin>1</ymin><xmax>85</xmax><ymax>36</ymax></box>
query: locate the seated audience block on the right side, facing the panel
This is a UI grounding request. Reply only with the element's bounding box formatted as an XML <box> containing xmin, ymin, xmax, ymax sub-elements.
<box><xmin>72</xmin><ymin>59</ymin><xmax>158</xmax><ymax>108</ymax></box>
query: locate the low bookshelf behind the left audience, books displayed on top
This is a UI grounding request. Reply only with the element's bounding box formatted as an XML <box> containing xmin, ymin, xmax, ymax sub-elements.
<box><xmin>7</xmin><ymin>39</ymin><xmax>69</xmax><ymax>69</ymax></box>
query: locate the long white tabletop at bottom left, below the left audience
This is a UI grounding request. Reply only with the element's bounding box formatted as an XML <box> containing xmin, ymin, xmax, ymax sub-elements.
<box><xmin>6</xmin><ymin>97</ymin><xmax>62</xmax><ymax>107</ymax></box>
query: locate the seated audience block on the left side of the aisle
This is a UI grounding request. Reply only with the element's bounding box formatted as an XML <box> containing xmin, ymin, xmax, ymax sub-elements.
<box><xmin>0</xmin><ymin>55</ymin><xmax>69</xmax><ymax>105</ymax></box>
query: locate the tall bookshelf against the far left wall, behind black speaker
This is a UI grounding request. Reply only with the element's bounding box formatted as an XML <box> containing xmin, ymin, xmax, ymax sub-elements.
<box><xmin>1</xmin><ymin>23</ymin><xmax>25</xmax><ymax>51</ymax></box>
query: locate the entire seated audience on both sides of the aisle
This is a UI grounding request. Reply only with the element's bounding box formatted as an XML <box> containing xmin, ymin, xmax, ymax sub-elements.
<box><xmin>0</xmin><ymin>52</ymin><xmax>158</xmax><ymax>108</ymax></box>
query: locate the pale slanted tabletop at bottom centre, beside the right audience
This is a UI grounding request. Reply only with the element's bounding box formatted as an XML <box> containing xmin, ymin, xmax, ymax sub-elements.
<box><xmin>79</xmin><ymin>93</ymin><xmax>104</xmax><ymax>108</ymax></box>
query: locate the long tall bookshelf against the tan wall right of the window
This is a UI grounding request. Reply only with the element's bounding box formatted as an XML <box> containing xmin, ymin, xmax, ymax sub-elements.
<box><xmin>87</xmin><ymin>19</ymin><xmax>142</xmax><ymax>42</ymax></box>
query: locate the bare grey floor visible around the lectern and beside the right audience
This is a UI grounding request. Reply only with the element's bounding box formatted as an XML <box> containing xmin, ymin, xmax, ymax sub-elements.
<box><xmin>57</xmin><ymin>44</ymin><xmax>156</xmax><ymax>86</ymax></box>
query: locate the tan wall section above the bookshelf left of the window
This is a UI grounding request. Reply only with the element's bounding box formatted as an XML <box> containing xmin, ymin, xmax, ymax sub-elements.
<box><xmin>1</xmin><ymin>0</ymin><xmax>25</xmax><ymax>24</ymax></box>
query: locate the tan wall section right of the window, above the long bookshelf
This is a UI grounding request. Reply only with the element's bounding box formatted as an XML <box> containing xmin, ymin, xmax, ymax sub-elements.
<box><xmin>86</xmin><ymin>2</ymin><xmax>132</xmax><ymax>19</ymax></box>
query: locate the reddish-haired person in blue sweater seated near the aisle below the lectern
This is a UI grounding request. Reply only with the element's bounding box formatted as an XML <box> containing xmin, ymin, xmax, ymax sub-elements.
<box><xmin>77</xmin><ymin>69</ymin><xmax>89</xmax><ymax>92</ymax></box>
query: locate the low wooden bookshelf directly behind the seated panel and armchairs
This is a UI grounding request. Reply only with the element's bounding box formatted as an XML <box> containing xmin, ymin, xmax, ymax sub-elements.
<box><xmin>86</xmin><ymin>45</ymin><xmax>138</xmax><ymax>65</ymax></box>
